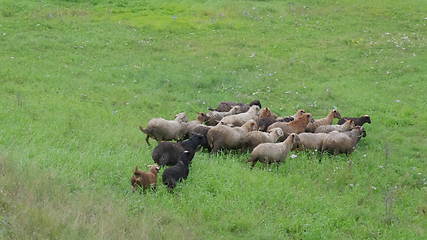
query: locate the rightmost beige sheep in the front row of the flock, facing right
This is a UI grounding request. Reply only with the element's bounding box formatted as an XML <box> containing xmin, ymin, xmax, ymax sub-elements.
<box><xmin>322</xmin><ymin>126</ymin><xmax>366</xmax><ymax>155</ymax></box>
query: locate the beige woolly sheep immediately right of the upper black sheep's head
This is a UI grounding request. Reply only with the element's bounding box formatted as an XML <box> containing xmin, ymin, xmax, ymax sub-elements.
<box><xmin>207</xmin><ymin>120</ymin><xmax>256</xmax><ymax>153</ymax></box>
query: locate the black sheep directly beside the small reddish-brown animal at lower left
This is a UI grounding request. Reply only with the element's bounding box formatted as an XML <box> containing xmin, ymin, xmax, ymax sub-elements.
<box><xmin>162</xmin><ymin>151</ymin><xmax>191</xmax><ymax>191</ymax></box>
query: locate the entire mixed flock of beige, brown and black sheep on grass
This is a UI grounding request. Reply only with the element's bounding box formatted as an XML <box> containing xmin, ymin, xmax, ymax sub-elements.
<box><xmin>131</xmin><ymin>100</ymin><xmax>371</xmax><ymax>191</ymax></box>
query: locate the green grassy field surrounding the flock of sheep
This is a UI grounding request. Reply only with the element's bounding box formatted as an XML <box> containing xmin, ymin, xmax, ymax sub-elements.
<box><xmin>0</xmin><ymin>0</ymin><xmax>427</xmax><ymax>239</ymax></box>
